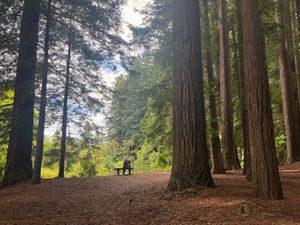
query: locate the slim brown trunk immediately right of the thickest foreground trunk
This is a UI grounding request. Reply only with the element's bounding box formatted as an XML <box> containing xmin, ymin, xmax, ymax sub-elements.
<box><xmin>203</xmin><ymin>0</ymin><xmax>225</xmax><ymax>174</ymax></box>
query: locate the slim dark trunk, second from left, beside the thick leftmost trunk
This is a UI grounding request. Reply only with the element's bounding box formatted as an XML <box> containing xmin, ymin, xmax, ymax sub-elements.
<box><xmin>32</xmin><ymin>0</ymin><xmax>51</xmax><ymax>184</ymax></box>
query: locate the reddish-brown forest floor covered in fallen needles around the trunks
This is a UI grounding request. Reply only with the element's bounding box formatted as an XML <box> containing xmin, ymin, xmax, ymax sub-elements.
<box><xmin>0</xmin><ymin>163</ymin><xmax>300</xmax><ymax>225</ymax></box>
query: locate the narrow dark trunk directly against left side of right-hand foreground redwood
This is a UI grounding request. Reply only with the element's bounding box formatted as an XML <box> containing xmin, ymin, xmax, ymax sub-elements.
<box><xmin>235</xmin><ymin>0</ymin><xmax>251</xmax><ymax>181</ymax></box>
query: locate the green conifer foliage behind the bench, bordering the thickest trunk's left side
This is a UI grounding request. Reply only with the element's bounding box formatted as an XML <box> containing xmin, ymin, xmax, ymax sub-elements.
<box><xmin>109</xmin><ymin>52</ymin><xmax>172</xmax><ymax>170</ymax></box>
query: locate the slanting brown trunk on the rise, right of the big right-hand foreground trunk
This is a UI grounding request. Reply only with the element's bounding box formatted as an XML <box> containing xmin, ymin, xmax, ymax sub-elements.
<box><xmin>278</xmin><ymin>0</ymin><xmax>300</xmax><ymax>163</ymax></box>
